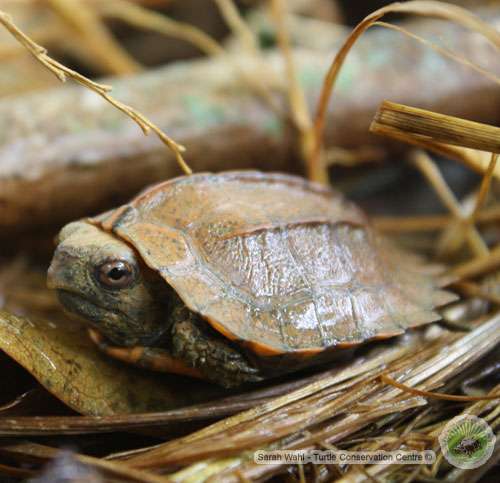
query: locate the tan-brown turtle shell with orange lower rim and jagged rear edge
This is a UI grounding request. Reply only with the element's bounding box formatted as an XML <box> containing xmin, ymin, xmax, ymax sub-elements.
<box><xmin>91</xmin><ymin>172</ymin><xmax>454</xmax><ymax>355</ymax></box>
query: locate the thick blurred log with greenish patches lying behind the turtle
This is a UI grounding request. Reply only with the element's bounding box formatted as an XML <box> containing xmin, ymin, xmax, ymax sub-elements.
<box><xmin>0</xmin><ymin>15</ymin><xmax>500</xmax><ymax>243</ymax></box>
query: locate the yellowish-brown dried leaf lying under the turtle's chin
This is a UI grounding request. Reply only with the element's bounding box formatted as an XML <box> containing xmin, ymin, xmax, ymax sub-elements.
<box><xmin>0</xmin><ymin>311</ymin><xmax>223</xmax><ymax>415</ymax></box>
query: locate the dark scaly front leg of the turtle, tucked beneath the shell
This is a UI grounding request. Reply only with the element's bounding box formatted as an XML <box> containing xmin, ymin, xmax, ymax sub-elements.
<box><xmin>170</xmin><ymin>309</ymin><xmax>263</xmax><ymax>387</ymax></box>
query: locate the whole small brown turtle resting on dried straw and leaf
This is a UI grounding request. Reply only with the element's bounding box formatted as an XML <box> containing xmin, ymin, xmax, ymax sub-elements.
<box><xmin>48</xmin><ymin>171</ymin><xmax>456</xmax><ymax>387</ymax></box>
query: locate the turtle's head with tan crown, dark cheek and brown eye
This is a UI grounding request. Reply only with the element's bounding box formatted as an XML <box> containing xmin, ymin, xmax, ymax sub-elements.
<box><xmin>48</xmin><ymin>221</ymin><xmax>169</xmax><ymax>346</ymax></box>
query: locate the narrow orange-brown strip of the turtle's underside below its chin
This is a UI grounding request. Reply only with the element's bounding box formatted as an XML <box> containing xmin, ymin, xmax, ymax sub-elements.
<box><xmin>89</xmin><ymin>329</ymin><xmax>204</xmax><ymax>379</ymax></box>
